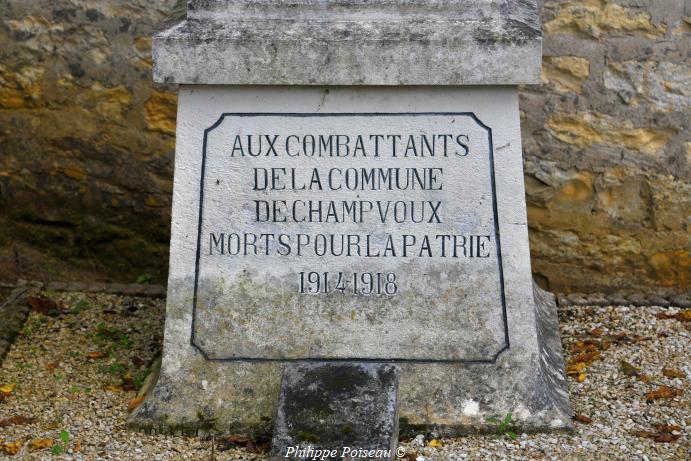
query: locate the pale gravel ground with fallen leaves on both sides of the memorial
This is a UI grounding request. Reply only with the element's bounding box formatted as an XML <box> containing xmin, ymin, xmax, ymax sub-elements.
<box><xmin>0</xmin><ymin>293</ymin><xmax>691</xmax><ymax>461</ymax></box>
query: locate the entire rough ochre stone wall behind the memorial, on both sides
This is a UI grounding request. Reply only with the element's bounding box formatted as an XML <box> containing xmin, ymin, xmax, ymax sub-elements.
<box><xmin>0</xmin><ymin>0</ymin><xmax>691</xmax><ymax>295</ymax></box>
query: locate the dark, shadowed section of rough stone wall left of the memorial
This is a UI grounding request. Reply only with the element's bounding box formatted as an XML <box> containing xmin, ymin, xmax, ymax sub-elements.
<box><xmin>0</xmin><ymin>0</ymin><xmax>179</xmax><ymax>281</ymax></box>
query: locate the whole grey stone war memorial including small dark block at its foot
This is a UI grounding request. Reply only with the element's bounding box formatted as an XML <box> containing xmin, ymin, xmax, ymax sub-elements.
<box><xmin>129</xmin><ymin>0</ymin><xmax>571</xmax><ymax>459</ymax></box>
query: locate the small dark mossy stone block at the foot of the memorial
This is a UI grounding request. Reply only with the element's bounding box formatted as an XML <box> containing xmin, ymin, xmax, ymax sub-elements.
<box><xmin>271</xmin><ymin>362</ymin><xmax>400</xmax><ymax>460</ymax></box>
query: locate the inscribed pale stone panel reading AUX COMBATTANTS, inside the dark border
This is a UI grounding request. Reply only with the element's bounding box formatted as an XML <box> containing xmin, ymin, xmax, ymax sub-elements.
<box><xmin>192</xmin><ymin>112</ymin><xmax>508</xmax><ymax>362</ymax></box>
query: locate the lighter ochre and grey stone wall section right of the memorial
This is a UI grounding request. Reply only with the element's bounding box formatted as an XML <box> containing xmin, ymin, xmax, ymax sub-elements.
<box><xmin>521</xmin><ymin>0</ymin><xmax>691</xmax><ymax>294</ymax></box>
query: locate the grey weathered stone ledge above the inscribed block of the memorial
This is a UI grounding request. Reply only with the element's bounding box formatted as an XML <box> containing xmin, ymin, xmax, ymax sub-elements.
<box><xmin>153</xmin><ymin>0</ymin><xmax>541</xmax><ymax>85</ymax></box>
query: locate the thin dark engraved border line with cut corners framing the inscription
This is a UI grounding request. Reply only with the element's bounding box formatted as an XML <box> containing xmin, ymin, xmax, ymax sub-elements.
<box><xmin>190</xmin><ymin>112</ymin><xmax>511</xmax><ymax>364</ymax></box>
